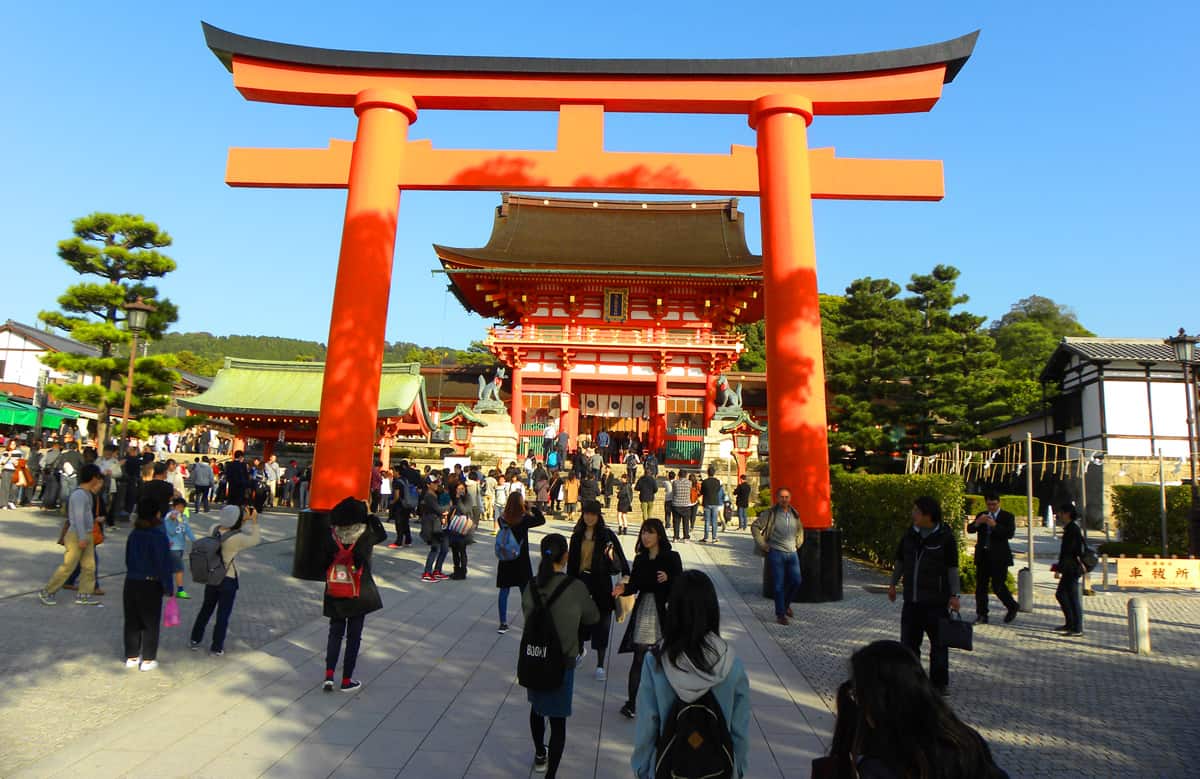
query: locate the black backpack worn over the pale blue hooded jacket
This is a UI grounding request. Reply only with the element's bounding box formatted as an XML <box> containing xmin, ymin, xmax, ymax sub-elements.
<box><xmin>654</xmin><ymin>690</ymin><xmax>734</xmax><ymax>779</ymax></box>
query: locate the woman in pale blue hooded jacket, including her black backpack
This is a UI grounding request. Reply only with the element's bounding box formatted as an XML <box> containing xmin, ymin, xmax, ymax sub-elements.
<box><xmin>632</xmin><ymin>570</ymin><xmax>750</xmax><ymax>779</ymax></box>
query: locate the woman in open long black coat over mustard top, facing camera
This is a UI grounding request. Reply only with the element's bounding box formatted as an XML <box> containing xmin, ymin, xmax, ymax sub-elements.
<box><xmin>566</xmin><ymin>499</ymin><xmax>630</xmax><ymax>682</ymax></box>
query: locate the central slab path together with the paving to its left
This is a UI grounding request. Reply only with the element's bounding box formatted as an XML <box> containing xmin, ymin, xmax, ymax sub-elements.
<box><xmin>0</xmin><ymin>506</ymin><xmax>832</xmax><ymax>779</ymax></box>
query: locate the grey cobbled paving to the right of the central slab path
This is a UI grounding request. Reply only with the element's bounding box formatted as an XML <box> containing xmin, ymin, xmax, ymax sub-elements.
<box><xmin>704</xmin><ymin>523</ymin><xmax>1200</xmax><ymax>777</ymax></box>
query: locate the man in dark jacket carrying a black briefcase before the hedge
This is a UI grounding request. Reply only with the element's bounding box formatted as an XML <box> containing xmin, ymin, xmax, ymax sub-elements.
<box><xmin>888</xmin><ymin>496</ymin><xmax>959</xmax><ymax>693</ymax></box>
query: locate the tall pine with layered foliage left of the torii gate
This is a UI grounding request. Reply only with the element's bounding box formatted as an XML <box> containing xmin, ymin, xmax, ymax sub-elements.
<box><xmin>37</xmin><ymin>212</ymin><xmax>179</xmax><ymax>441</ymax></box>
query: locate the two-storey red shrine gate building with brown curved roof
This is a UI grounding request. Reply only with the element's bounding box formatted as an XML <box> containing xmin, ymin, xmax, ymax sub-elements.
<box><xmin>434</xmin><ymin>194</ymin><xmax>763</xmax><ymax>466</ymax></box>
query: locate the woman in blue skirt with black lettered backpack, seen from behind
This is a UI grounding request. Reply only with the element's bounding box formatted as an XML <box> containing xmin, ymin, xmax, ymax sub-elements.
<box><xmin>517</xmin><ymin>533</ymin><xmax>600</xmax><ymax>779</ymax></box>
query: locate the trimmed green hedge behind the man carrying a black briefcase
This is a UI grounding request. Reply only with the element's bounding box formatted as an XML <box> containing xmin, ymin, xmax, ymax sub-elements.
<box><xmin>833</xmin><ymin>471</ymin><xmax>964</xmax><ymax>565</ymax></box>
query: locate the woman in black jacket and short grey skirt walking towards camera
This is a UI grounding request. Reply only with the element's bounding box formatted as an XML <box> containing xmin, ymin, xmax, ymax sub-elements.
<box><xmin>612</xmin><ymin>517</ymin><xmax>683</xmax><ymax>719</ymax></box>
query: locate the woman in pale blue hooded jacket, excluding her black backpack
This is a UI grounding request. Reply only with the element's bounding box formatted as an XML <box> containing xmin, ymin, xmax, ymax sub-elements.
<box><xmin>632</xmin><ymin>570</ymin><xmax>750</xmax><ymax>779</ymax></box>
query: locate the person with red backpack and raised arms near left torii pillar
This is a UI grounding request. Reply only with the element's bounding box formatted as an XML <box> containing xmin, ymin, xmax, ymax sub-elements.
<box><xmin>322</xmin><ymin>498</ymin><xmax>388</xmax><ymax>693</ymax></box>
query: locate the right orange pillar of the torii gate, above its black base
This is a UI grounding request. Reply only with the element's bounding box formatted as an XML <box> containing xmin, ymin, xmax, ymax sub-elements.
<box><xmin>750</xmin><ymin>95</ymin><xmax>833</xmax><ymax>528</ymax></box>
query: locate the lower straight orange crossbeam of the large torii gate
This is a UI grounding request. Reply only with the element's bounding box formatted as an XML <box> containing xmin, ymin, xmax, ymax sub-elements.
<box><xmin>226</xmin><ymin>140</ymin><xmax>944</xmax><ymax>200</ymax></box>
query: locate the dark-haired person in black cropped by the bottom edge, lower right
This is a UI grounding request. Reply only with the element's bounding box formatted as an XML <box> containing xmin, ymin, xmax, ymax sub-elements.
<box><xmin>835</xmin><ymin>641</ymin><xmax>1008</xmax><ymax>779</ymax></box>
